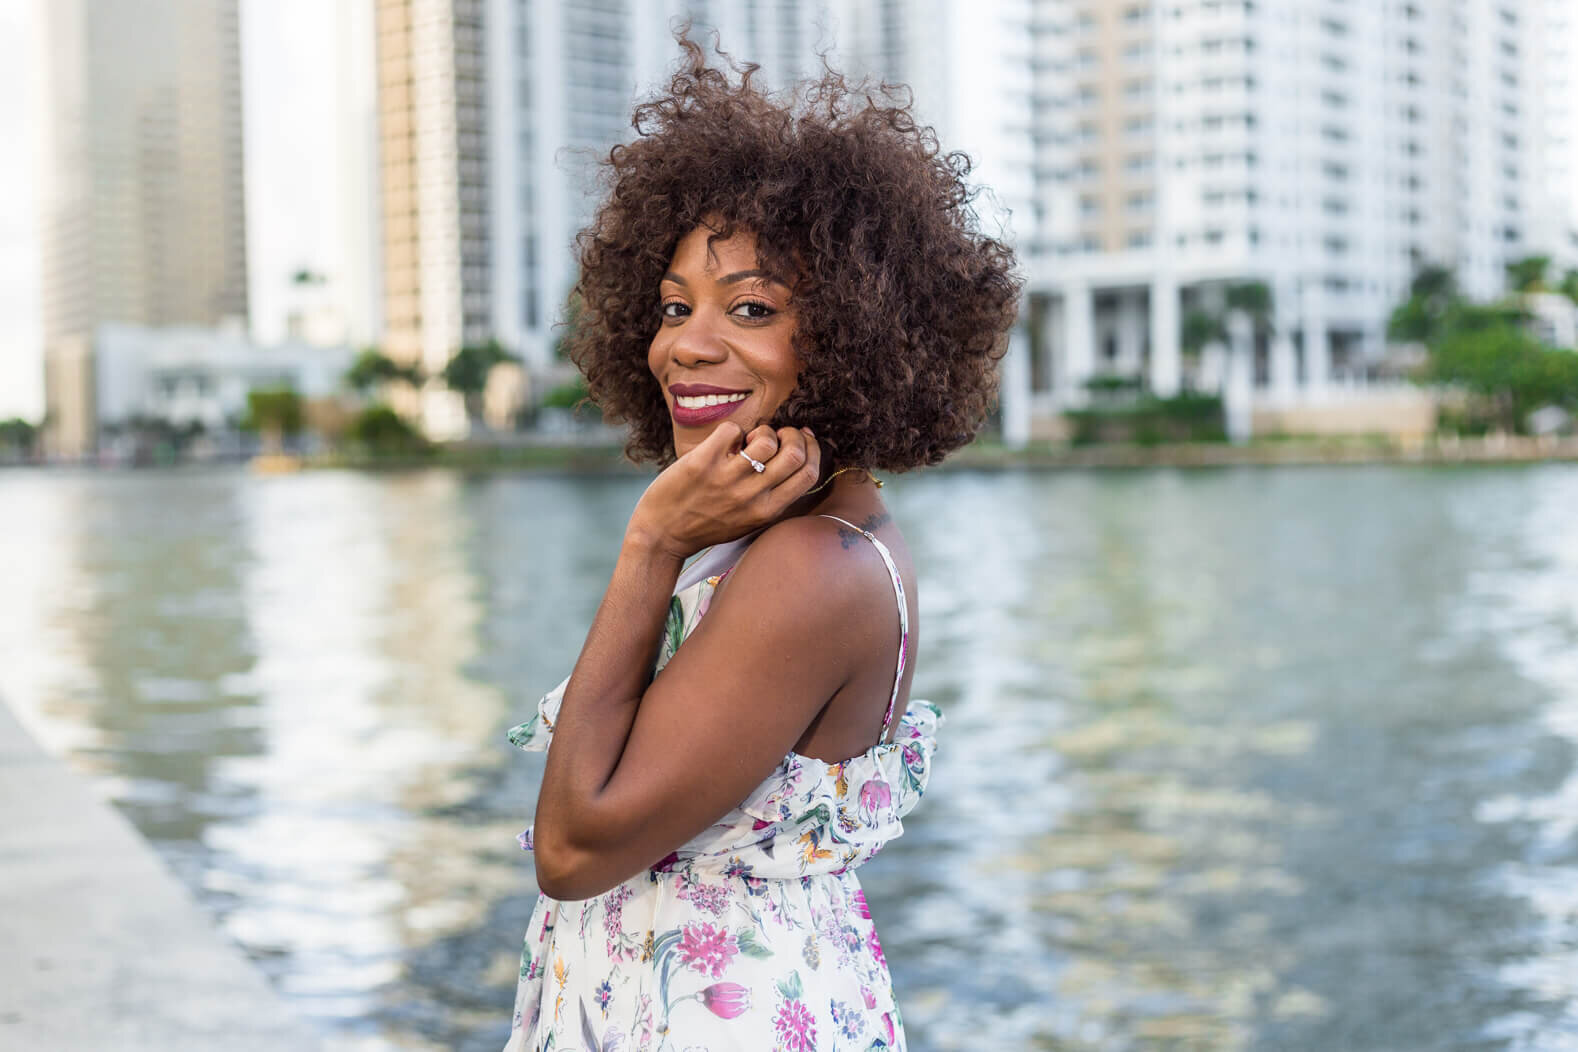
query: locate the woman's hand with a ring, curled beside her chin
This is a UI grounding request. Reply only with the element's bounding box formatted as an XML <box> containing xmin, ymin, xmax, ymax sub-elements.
<box><xmin>625</xmin><ymin>420</ymin><xmax>822</xmax><ymax>560</ymax></box>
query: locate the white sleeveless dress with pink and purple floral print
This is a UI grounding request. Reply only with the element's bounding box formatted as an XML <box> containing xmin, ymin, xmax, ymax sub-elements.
<box><xmin>505</xmin><ymin>516</ymin><xmax>942</xmax><ymax>1052</ymax></box>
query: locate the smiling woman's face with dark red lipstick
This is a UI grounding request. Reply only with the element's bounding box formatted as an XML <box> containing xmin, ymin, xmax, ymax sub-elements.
<box><xmin>647</xmin><ymin>224</ymin><xmax>800</xmax><ymax>456</ymax></box>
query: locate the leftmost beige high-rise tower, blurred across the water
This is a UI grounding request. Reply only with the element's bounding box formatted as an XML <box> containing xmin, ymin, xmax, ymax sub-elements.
<box><xmin>41</xmin><ymin>0</ymin><xmax>248</xmax><ymax>456</ymax></box>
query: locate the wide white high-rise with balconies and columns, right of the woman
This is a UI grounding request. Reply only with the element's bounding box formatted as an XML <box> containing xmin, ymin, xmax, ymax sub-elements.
<box><xmin>1027</xmin><ymin>0</ymin><xmax>1571</xmax><ymax>405</ymax></box>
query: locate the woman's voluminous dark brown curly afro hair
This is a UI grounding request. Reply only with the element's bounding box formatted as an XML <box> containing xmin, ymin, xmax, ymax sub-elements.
<box><xmin>567</xmin><ymin>35</ymin><xmax>1021</xmax><ymax>472</ymax></box>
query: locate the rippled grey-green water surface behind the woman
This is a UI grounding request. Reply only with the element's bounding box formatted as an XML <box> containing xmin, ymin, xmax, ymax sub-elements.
<box><xmin>0</xmin><ymin>467</ymin><xmax>1578</xmax><ymax>1052</ymax></box>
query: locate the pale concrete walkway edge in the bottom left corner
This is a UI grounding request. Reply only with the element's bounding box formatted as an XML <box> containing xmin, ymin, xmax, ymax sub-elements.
<box><xmin>0</xmin><ymin>693</ymin><xmax>319</xmax><ymax>1052</ymax></box>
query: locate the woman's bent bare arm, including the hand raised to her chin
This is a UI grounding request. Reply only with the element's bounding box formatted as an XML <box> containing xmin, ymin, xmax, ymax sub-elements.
<box><xmin>535</xmin><ymin>427</ymin><xmax>849</xmax><ymax>899</ymax></box>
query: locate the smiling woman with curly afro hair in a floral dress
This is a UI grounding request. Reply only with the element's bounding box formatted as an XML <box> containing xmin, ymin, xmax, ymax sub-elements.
<box><xmin>508</xmin><ymin>41</ymin><xmax>1018</xmax><ymax>1052</ymax></box>
